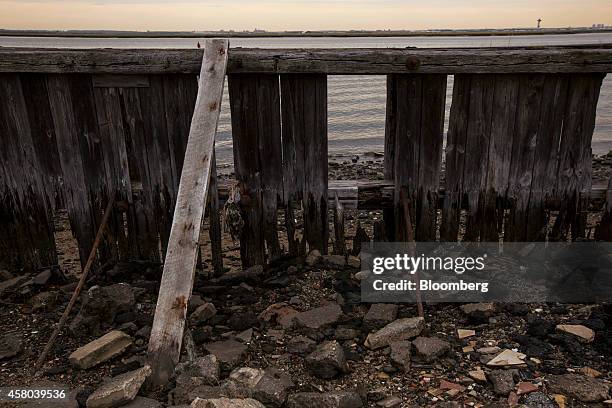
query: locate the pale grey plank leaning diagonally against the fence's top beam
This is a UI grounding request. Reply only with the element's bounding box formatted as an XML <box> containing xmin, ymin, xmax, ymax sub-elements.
<box><xmin>148</xmin><ymin>39</ymin><xmax>229</xmax><ymax>385</ymax></box>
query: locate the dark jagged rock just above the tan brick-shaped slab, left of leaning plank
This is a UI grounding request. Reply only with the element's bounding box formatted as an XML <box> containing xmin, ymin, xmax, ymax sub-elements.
<box><xmin>70</xmin><ymin>283</ymin><xmax>136</xmax><ymax>335</ymax></box>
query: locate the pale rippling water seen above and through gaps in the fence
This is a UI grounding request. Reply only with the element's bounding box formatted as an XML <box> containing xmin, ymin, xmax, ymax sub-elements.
<box><xmin>0</xmin><ymin>33</ymin><xmax>612</xmax><ymax>164</ymax></box>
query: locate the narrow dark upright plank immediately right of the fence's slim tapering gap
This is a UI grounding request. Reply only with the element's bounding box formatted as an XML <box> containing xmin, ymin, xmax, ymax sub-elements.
<box><xmin>440</xmin><ymin>75</ymin><xmax>472</xmax><ymax>242</ymax></box>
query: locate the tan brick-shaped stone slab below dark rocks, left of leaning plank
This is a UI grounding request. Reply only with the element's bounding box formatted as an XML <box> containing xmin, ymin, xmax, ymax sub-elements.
<box><xmin>68</xmin><ymin>330</ymin><xmax>132</xmax><ymax>370</ymax></box>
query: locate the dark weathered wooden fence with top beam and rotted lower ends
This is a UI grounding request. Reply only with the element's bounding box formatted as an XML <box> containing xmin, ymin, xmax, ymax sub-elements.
<box><xmin>0</xmin><ymin>45</ymin><xmax>612</xmax><ymax>272</ymax></box>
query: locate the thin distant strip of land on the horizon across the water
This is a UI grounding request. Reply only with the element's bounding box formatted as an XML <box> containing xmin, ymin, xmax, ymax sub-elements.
<box><xmin>0</xmin><ymin>27</ymin><xmax>612</xmax><ymax>38</ymax></box>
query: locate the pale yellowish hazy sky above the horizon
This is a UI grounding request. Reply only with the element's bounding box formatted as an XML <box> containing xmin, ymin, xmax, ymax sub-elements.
<box><xmin>0</xmin><ymin>0</ymin><xmax>612</xmax><ymax>31</ymax></box>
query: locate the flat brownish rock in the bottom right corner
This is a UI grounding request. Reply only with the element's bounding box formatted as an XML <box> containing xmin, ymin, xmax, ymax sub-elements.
<box><xmin>548</xmin><ymin>374</ymin><xmax>610</xmax><ymax>402</ymax></box>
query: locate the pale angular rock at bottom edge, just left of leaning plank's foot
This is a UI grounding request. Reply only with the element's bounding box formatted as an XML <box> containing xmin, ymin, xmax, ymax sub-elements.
<box><xmin>87</xmin><ymin>366</ymin><xmax>151</xmax><ymax>408</ymax></box>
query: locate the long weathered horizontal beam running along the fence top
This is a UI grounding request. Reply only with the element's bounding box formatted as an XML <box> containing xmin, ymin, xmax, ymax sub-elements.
<box><xmin>0</xmin><ymin>44</ymin><xmax>612</xmax><ymax>75</ymax></box>
